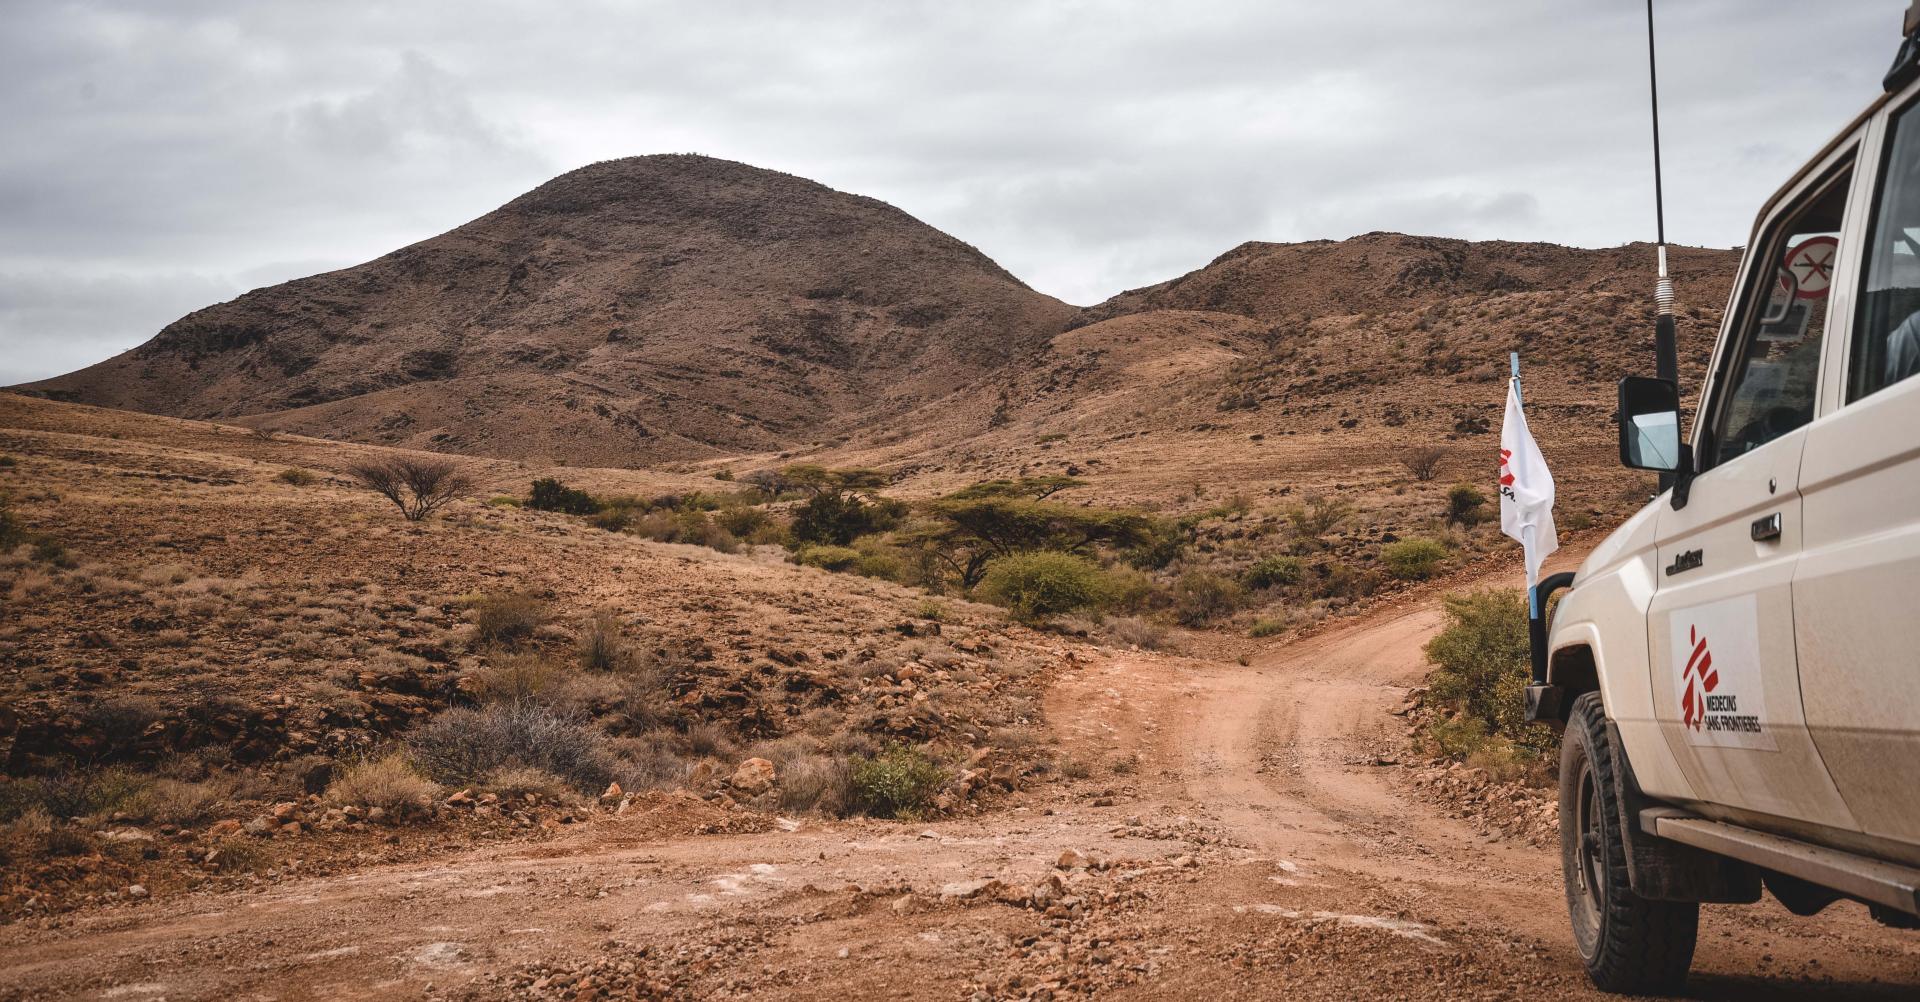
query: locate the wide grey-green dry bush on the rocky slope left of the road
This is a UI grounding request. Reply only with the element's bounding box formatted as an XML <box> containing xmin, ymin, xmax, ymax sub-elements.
<box><xmin>407</xmin><ymin>703</ymin><xmax>614</xmax><ymax>793</ymax></box>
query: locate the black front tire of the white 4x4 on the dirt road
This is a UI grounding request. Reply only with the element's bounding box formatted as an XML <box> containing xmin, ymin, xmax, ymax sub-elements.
<box><xmin>1559</xmin><ymin>693</ymin><xmax>1699</xmax><ymax>994</ymax></box>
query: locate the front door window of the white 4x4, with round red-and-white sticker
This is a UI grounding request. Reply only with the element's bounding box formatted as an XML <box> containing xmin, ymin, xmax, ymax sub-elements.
<box><xmin>1701</xmin><ymin>175</ymin><xmax>1847</xmax><ymax>468</ymax></box>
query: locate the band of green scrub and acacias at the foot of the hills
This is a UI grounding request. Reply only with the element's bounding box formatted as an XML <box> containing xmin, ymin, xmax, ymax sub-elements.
<box><xmin>524</xmin><ymin>449</ymin><xmax>1498</xmax><ymax>647</ymax></box>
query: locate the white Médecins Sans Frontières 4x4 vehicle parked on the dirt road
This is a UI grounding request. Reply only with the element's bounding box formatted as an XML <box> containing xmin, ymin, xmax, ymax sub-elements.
<box><xmin>1528</xmin><ymin>2</ymin><xmax>1920</xmax><ymax>992</ymax></box>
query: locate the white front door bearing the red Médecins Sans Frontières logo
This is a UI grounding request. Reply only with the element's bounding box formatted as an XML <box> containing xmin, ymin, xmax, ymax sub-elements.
<box><xmin>1647</xmin><ymin>144</ymin><xmax>1855</xmax><ymax>825</ymax></box>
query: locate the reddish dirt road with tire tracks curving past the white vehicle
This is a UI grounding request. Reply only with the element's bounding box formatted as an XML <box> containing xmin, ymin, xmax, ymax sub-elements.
<box><xmin>0</xmin><ymin>605</ymin><xmax>1920</xmax><ymax>1000</ymax></box>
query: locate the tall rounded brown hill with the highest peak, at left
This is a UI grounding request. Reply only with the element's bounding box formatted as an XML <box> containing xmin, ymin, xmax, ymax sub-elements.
<box><xmin>27</xmin><ymin>155</ymin><xmax>1073</xmax><ymax>465</ymax></box>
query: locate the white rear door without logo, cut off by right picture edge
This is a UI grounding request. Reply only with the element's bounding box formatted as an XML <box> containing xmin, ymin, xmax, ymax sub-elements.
<box><xmin>1793</xmin><ymin>91</ymin><xmax>1920</xmax><ymax>845</ymax></box>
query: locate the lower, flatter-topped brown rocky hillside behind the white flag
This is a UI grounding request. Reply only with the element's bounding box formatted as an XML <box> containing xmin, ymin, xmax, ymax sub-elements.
<box><xmin>802</xmin><ymin>234</ymin><xmax>1740</xmax><ymax>524</ymax></box>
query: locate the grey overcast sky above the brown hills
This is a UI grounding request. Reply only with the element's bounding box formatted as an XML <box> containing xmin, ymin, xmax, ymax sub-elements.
<box><xmin>0</xmin><ymin>0</ymin><xmax>1905</xmax><ymax>384</ymax></box>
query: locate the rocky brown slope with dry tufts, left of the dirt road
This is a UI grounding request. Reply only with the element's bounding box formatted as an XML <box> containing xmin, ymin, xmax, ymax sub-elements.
<box><xmin>0</xmin><ymin>395</ymin><xmax>1092</xmax><ymax>919</ymax></box>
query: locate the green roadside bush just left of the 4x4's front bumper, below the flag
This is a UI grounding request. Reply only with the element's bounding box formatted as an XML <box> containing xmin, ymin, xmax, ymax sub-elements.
<box><xmin>1427</xmin><ymin>589</ymin><xmax>1553</xmax><ymax>751</ymax></box>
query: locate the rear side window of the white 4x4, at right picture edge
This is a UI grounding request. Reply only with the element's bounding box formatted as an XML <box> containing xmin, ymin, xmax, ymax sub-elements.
<box><xmin>1847</xmin><ymin>106</ymin><xmax>1920</xmax><ymax>401</ymax></box>
